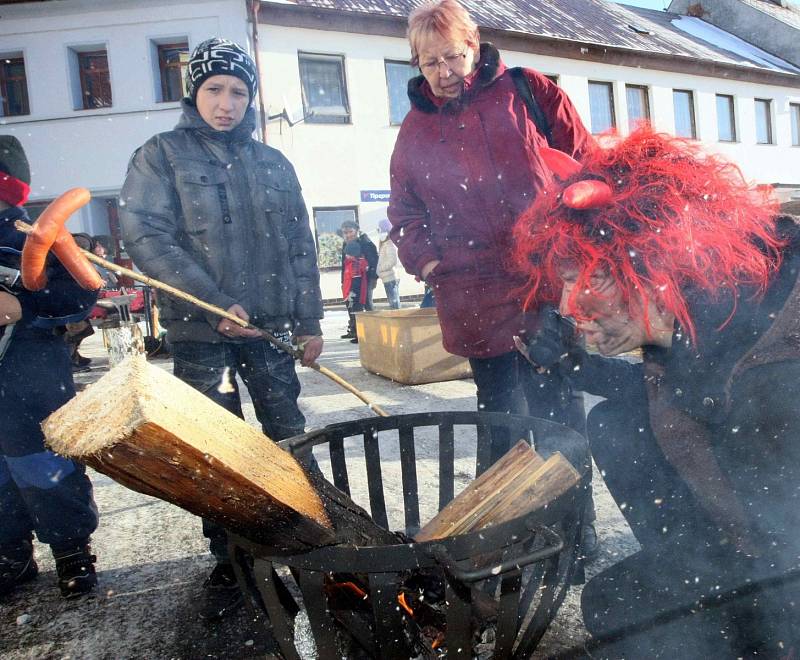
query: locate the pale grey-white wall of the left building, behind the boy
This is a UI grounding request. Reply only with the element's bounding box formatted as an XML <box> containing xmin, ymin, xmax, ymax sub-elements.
<box><xmin>0</xmin><ymin>0</ymin><xmax>248</xmax><ymax>234</ymax></box>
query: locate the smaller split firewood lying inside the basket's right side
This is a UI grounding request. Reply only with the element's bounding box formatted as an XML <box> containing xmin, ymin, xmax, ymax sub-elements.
<box><xmin>415</xmin><ymin>440</ymin><xmax>580</xmax><ymax>541</ymax></box>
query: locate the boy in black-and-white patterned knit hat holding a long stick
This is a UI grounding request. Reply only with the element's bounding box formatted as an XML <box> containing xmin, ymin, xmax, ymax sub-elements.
<box><xmin>120</xmin><ymin>38</ymin><xmax>322</xmax><ymax>616</ymax></box>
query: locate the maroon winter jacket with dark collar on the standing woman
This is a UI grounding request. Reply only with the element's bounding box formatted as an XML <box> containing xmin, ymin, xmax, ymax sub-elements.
<box><xmin>389</xmin><ymin>44</ymin><xmax>592</xmax><ymax>357</ymax></box>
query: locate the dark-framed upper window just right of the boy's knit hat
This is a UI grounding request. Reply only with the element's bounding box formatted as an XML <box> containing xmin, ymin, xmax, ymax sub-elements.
<box><xmin>298</xmin><ymin>53</ymin><xmax>350</xmax><ymax>124</ymax></box>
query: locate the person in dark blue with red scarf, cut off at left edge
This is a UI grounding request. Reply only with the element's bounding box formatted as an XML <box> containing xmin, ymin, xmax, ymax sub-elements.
<box><xmin>0</xmin><ymin>135</ymin><xmax>98</xmax><ymax>598</ymax></box>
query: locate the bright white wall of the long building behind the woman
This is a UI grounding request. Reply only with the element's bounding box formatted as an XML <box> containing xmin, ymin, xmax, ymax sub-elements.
<box><xmin>259</xmin><ymin>24</ymin><xmax>800</xmax><ymax>292</ymax></box>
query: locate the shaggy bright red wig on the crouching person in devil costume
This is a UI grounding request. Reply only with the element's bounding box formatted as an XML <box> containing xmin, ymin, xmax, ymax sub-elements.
<box><xmin>514</xmin><ymin>126</ymin><xmax>782</xmax><ymax>339</ymax></box>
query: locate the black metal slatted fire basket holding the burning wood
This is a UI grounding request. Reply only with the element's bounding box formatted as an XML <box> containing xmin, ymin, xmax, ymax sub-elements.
<box><xmin>230</xmin><ymin>412</ymin><xmax>590</xmax><ymax>660</ymax></box>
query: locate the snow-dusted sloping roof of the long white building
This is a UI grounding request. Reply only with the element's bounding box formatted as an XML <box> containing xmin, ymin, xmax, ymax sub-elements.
<box><xmin>262</xmin><ymin>0</ymin><xmax>800</xmax><ymax>74</ymax></box>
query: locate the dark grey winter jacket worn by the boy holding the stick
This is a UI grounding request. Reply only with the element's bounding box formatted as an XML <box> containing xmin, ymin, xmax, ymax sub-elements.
<box><xmin>120</xmin><ymin>99</ymin><xmax>322</xmax><ymax>342</ymax></box>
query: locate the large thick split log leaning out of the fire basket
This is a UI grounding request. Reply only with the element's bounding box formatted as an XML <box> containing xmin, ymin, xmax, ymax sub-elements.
<box><xmin>43</xmin><ymin>357</ymin><xmax>398</xmax><ymax>553</ymax></box>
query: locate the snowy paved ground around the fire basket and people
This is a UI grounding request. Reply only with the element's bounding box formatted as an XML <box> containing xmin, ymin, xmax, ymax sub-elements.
<box><xmin>0</xmin><ymin>310</ymin><xmax>637</xmax><ymax>660</ymax></box>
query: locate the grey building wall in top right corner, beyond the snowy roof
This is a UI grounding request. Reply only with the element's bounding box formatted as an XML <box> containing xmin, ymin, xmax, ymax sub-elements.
<box><xmin>669</xmin><ymin>0</ymin><xmax>800</xmax><ymax>66</ymax></box>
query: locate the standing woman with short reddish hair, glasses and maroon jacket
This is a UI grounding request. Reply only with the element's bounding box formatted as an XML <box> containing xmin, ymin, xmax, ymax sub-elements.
<box><xmin>388</xmin><ymin>0</ymin><xmax>597</xmax><ymax>556</ymax></box>
